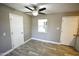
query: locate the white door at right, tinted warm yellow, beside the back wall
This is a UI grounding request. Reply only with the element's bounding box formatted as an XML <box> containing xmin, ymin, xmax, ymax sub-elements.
<box><xmin>60</xmin><ymin>16</ymin><xmax>79</xmax><ymax>46</ymax></box>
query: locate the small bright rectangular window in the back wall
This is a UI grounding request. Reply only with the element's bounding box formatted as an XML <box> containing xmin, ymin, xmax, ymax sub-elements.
<box><xmin>38</xmin><ymin>19</ymin><xmax>47</xmax><ymax>33</ymax></box>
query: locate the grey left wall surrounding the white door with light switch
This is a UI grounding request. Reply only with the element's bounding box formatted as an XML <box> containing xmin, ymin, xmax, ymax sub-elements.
<box><xmin>0</xmin><ymin>4</ymin><xmax>31</xmax><ymax>52</ymax></box>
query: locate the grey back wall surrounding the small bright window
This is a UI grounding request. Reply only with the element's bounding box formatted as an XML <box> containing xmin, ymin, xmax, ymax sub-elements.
<box><xmin>32</xmin><ymin>12</ymin><xmax>79</xmax><ymax>42</ymax></box>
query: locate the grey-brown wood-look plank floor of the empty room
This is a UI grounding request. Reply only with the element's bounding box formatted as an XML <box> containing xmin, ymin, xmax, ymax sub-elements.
<box><xmin>6</xmin><ymin>40</ymin><xmax>79</xmax><ymax>56</ymax></box>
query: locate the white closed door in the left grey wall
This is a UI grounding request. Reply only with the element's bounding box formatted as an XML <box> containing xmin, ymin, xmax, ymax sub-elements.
<box><xmin>10</xmin><ymin>14</ymin><xmax>24</xmax><ymax>48</ymax></box>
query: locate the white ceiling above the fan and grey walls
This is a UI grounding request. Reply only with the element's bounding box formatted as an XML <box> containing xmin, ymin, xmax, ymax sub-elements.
<box><xmin>5</xmin><ymin>3</ymin><xmax>79</xmax><ymax>14</ymax></box>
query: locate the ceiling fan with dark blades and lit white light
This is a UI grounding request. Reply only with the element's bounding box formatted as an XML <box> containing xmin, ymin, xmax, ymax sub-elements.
<box><xmin>25</xmin><ymin>5</ymin><xmax>46</xmax><ymax>16</ymax></box>
